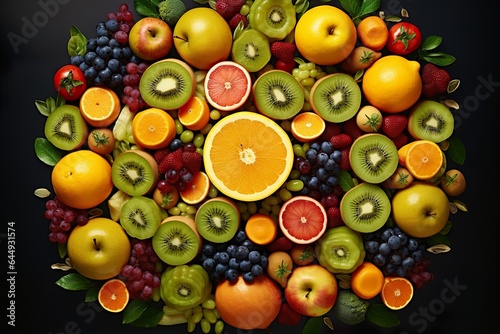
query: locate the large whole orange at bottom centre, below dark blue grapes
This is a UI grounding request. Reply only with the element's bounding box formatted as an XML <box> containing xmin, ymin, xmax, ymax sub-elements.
<box><xmin>215</xmin><ymin>274</ymin><xmax>282</xmax><ymax>330</ymax></box>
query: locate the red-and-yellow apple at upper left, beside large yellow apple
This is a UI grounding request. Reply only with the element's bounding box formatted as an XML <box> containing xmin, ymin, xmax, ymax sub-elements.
<box><xmin>128</xmin><ymin>17</ymin><xmax>173</xmax><ymax>61</ymax></box>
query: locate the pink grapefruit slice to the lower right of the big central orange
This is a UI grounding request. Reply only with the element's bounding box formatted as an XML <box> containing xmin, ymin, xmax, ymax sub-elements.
<box><xmin>278</xmin><ymin>196</ymin><xmax>328</xmax><ymax>244</ymax></box>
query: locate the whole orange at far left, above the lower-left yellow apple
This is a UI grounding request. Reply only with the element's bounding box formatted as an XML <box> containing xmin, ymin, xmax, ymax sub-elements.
<box><xmin>51</xmin><ymin>150</ymin><xmax>113</xmax><ymax>209</ymax></box>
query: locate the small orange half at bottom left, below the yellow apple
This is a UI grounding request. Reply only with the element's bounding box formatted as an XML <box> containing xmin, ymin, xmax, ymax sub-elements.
<box><xmin>97</xmin><ymin>278</ymin><xmax>130</xmax><ymax>313</ymax></box>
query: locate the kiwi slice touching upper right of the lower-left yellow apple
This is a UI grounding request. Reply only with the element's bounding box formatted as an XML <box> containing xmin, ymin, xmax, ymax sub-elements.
<box><xmin>120</xmin><ymin>196</ymin><xmax>162</xmax><ymax>240</ymax></box>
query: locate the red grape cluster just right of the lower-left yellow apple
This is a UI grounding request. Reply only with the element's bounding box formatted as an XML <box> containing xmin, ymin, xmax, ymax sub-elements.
<box><xmin>120</xmin><ymin>239</ymin><xmax>161</xmax><ymax>301</ymax></box>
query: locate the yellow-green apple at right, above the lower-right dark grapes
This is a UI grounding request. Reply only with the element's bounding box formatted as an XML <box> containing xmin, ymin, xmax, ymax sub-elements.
<box><xmin>391</xmin><ymin>181</ymin><xmax>450</xmax><ymax>238</ymax></box>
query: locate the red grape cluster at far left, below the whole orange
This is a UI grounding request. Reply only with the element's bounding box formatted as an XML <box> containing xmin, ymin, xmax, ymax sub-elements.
<box><xmin>44</xmin><ymin>197</ymin><xmax>89</xmax><ymax>244</ymax></box>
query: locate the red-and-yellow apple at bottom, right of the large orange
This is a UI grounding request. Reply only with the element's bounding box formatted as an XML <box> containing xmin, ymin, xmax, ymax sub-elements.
<box><xmin>285</xmin><ymin>264</ymin><xmax>338</xmax><ymax>317</ymax></box>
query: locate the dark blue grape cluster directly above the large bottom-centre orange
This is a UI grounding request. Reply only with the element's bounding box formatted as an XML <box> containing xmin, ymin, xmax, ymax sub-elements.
<box><xmin>200</xmin><ymin>230</ymin><xmax>267</xmax><ymax>282</ymax></box>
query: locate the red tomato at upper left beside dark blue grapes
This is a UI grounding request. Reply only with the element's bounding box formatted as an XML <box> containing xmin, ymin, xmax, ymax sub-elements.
<box><xmin>54</xmin><ymin>64</ymin><xmax>87</xmax><ymax>101</ymax></box>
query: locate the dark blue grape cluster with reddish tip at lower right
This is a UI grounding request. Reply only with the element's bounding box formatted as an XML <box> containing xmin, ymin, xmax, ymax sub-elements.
<box><xmin>363</xmin><ymin>226</ymin><xmax>433</xmax><ymax>287</ymax></box>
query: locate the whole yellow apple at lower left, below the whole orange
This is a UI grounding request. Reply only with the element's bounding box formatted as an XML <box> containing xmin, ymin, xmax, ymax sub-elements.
<box><xmin>67</xmin><ymin>217</ymin><xmax>131</xmax><ymax>280</ymax></box>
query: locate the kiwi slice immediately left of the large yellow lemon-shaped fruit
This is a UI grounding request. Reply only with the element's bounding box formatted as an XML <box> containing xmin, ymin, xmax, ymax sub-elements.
<box><xmin>310</xmin><ymin>73</ymin><xmax>361</xmax><ymax>123</ymax></box>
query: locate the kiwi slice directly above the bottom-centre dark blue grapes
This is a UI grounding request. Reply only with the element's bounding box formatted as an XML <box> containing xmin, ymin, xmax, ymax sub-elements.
<box><xmin>194</xmin><ymin>196</ymin><xmax>240</xmax><ymax>243</ymax></box>
